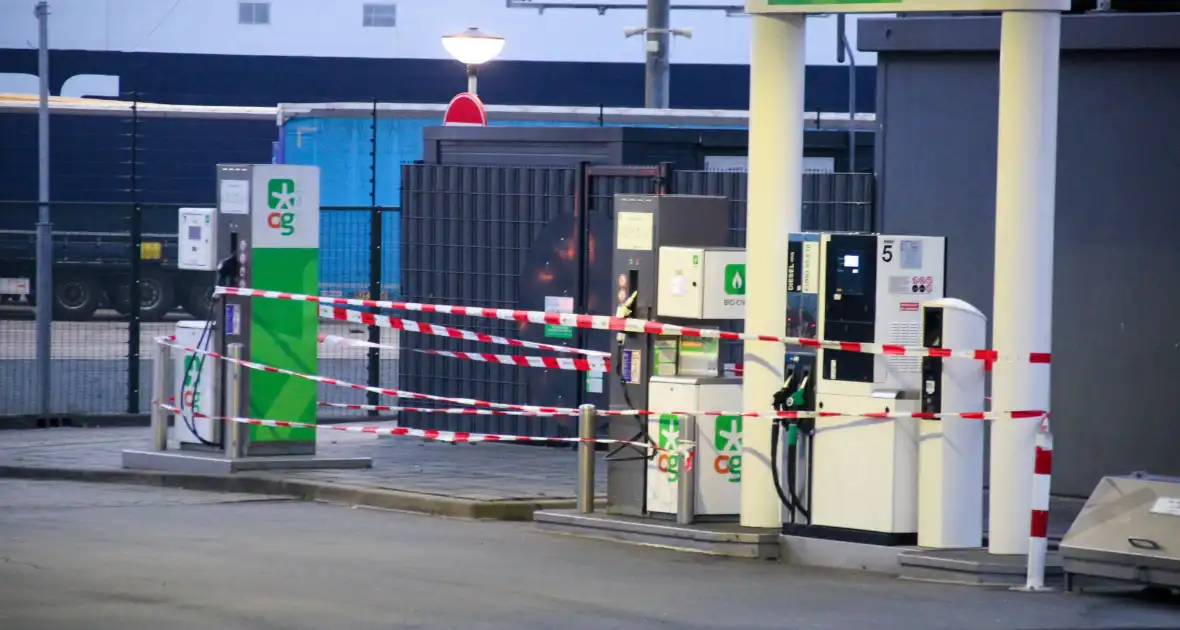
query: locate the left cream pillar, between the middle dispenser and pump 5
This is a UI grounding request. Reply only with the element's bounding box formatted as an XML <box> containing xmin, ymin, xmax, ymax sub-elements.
<box><xmin>741</xmin><ymin>15</ymin><xmax>806</xmax><ymax>529</ymax></box>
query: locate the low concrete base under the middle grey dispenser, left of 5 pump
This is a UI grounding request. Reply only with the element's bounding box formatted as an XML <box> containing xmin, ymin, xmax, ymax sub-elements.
<box><xmin>532</xmin><ymin>510</ymin><xmax>779</xmax><ymax>560</ymax></box>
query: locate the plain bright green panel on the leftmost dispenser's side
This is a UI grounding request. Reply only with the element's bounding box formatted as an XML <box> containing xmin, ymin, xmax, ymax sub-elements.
<box><xmin>247</xmin><ymin>249</ymin><xmax>320</xmax><ymax>442</ymax></box>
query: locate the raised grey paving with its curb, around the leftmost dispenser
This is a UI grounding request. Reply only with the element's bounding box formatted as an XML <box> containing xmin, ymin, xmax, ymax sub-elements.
<box><xmin>0</xmin><ymin>424</ymin><xmax>605</xmax><ymax>520</ymax></box>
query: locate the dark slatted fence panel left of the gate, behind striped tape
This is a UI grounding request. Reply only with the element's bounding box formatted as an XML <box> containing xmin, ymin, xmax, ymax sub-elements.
<box><xmin>393</xmin><ymin>164</ymin><xmax>577</xmax><ymax>434</ymax></box>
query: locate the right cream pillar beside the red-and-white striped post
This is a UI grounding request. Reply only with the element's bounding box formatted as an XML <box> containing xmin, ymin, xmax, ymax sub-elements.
<box><xmin>988</xmin><ymin>12</ymin><xmax>1061</xmax><ymax>554</ymax></box>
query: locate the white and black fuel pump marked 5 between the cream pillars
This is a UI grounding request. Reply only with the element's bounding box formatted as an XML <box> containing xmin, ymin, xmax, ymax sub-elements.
<box><xmin>774</xmin><ymin>234</ymin><xmax>953</xmax><ymax>544</ymax></box>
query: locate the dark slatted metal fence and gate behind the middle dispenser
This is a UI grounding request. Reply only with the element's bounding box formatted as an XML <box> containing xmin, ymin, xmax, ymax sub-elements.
<box><xmin>400</xmin><ymin>164</ymin><xmax>874</xmax><ymax>435</ymax></box>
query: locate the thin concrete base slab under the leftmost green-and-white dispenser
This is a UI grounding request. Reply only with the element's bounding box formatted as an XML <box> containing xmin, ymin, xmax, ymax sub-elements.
<box><xmin>123</xmin><ymin>451</ymin><xmax>373</xmax><ymax>474</ymax></box>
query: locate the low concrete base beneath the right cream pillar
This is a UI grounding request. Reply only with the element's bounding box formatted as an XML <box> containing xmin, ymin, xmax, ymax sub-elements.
<box><xmin>898</xmin><ymin>547</ymin><xmax>1063</xmax><ymax>588</ymax></box>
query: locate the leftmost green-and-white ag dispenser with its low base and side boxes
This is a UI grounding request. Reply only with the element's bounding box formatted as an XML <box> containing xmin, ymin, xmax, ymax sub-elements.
<box><xmin>124</xmin><ymin>164</ymin><xmax>371</xmax><ymax>472</ymax></box>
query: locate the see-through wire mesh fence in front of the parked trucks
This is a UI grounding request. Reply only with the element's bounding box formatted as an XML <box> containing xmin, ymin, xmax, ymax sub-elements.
<box><xmin>0</xmin><ymin>202</ymin><xmax>399</xmax><ymax>416</ymax></box>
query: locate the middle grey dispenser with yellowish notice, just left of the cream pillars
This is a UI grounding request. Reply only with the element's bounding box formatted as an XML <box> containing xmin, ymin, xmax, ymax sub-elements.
<box><xmin>607</xmin><ymin>195</ymin><xmax>745</xmax><ymax>516</ymax></box>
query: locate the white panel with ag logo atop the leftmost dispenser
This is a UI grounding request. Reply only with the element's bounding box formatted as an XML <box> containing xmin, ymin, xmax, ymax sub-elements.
<box><xmin>251</xmin><ymin>164</ymin><xmax>320</xmax><ymax>249</ymax></box>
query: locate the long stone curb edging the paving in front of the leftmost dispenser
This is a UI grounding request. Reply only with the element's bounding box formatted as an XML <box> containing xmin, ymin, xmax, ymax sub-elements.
<box><xmin>0</xmin><ymin>466</ymin><xmax>599</xmax><ymax>521</ymax></box>
